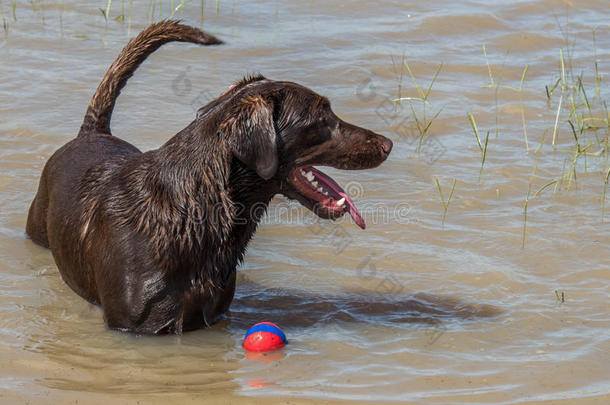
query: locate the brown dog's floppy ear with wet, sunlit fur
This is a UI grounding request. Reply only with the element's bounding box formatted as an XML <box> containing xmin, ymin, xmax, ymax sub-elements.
<box><xmin>221</xmin><ymin>94</ymin><xmax>278</xmax><ymax>180</ymax></box>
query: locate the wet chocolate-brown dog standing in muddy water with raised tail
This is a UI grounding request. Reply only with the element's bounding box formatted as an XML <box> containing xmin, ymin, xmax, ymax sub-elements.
<box><xmin>26</xmin><ymin>21</ymin><xmax>392</xmax><ymax>334</ymax></box>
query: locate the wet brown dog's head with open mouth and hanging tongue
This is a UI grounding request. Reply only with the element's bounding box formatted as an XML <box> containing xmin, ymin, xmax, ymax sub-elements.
<box><xmin>198</xmin><ymin>76</ymin><xmax>392</xmax><ymax>229</ymax></box>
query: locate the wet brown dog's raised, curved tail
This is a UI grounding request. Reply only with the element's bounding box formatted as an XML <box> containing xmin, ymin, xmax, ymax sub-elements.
<box><xmin>79</xmin><ymin>20</ymin><xmax>222</xmax><ymax>135</ymax></box>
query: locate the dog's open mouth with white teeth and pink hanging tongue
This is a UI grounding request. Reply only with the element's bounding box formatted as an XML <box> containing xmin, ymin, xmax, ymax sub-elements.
<box><xmin>288</xmin><ymin>166</ymin><xmax>366</xmax><ymax>229</ymax></box>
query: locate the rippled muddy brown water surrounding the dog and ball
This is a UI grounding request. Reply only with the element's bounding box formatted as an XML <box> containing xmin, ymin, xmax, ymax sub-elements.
<box><xmin>0</xmin><ymin>0</ymin><xmax>610</xmax><ymax>404</ymax></box>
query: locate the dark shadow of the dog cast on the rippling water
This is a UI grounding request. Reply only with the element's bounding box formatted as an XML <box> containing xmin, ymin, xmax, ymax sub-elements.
<box><xmin>221</xmin><ymin>275</ymin><xmax>502</xmax><ymax>330</ymax></box>
